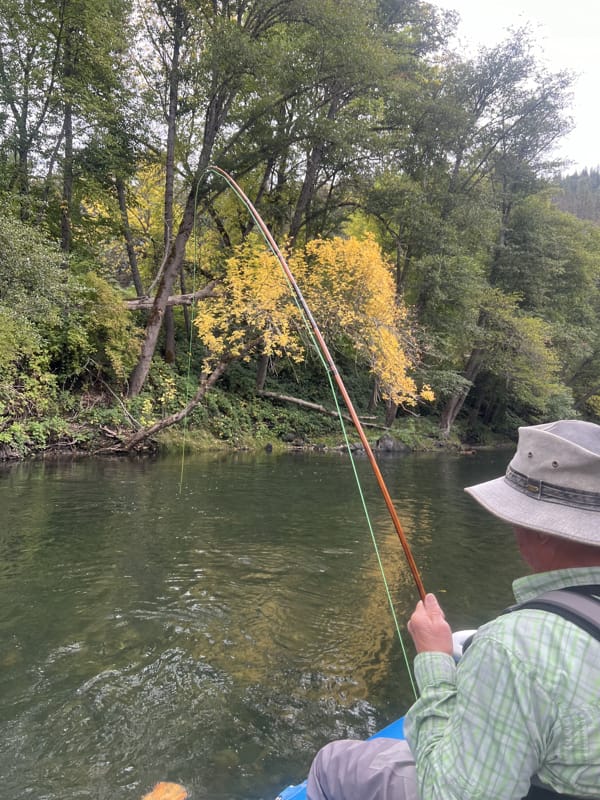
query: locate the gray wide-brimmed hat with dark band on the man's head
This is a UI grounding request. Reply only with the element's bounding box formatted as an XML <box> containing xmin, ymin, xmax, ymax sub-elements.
<box><xmin>465</xmin><ymin>420</ymin><xmax>600</xmax><ymax>547</ymax></box>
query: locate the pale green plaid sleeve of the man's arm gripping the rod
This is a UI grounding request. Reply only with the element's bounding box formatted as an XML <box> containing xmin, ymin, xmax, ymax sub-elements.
<box><xmin>405</xmin><ymin>633</ymin><xmax>551</xmax><ymax>800</ymax></box>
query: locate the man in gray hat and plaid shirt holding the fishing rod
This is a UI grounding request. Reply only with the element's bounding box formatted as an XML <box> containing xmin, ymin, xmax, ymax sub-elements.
<box><xmin>307</xmin><ymin>420</ymin><xmax>600</xmax><ymax>800</ymax></box>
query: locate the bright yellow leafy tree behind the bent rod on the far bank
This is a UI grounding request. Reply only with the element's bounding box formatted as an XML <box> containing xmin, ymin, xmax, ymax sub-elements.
<box><xmin>196</xmin><ymin>231</ymin><xmax>433</xmax><ymax>406</ymax></box>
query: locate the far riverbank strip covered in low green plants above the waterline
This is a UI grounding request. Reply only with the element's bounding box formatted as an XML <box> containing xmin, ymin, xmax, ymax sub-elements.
<box><xmin>0</xmin><ymin>390</ymin><xmax>507</xmax><ymax>462</ymax></box>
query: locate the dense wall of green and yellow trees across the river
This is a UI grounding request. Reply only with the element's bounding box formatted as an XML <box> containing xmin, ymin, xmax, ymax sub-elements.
<box><xmin>0</xmin><ymin>0</ymin><xmax>600</xmax><ymax>455</ymax></box>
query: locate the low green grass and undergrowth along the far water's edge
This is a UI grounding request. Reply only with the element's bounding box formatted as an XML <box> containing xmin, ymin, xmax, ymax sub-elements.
<box><xmin>0</xmin><ymin>380</ymin><xmax>460</xmax><ymax>459</ymax></box>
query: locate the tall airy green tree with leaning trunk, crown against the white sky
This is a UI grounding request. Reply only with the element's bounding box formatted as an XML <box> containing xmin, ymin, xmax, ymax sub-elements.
<box><xmin>396</xmin><ymin>31</ymin><xmax>570</xmax><ymax>434</ymax></box>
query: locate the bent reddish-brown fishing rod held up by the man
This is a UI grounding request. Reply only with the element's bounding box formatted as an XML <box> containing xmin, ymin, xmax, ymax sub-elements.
<box><xmin>208</xmin><ymin>166</ymin><xmax>425</xmax><ymax>600</ymax></box>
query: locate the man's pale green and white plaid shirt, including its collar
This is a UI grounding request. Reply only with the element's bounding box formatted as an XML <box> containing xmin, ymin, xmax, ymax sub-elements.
<box><xmin>405</xmin><ymin>567</ymin><xmax>600</xmax><ymax>800</ymax></box>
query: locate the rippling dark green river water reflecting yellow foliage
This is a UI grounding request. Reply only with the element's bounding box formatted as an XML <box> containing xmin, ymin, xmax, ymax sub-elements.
<box><xmin>0</xmin><ymin>450</ymin><xmax>525</xmax><ymax>800</ymax></box>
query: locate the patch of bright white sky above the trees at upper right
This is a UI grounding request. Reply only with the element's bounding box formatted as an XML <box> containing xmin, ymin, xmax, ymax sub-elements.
<box><xmin>432</xmin><ymin>0</ymin><xmax>600</xmax><ymax>173</ymax></box>
